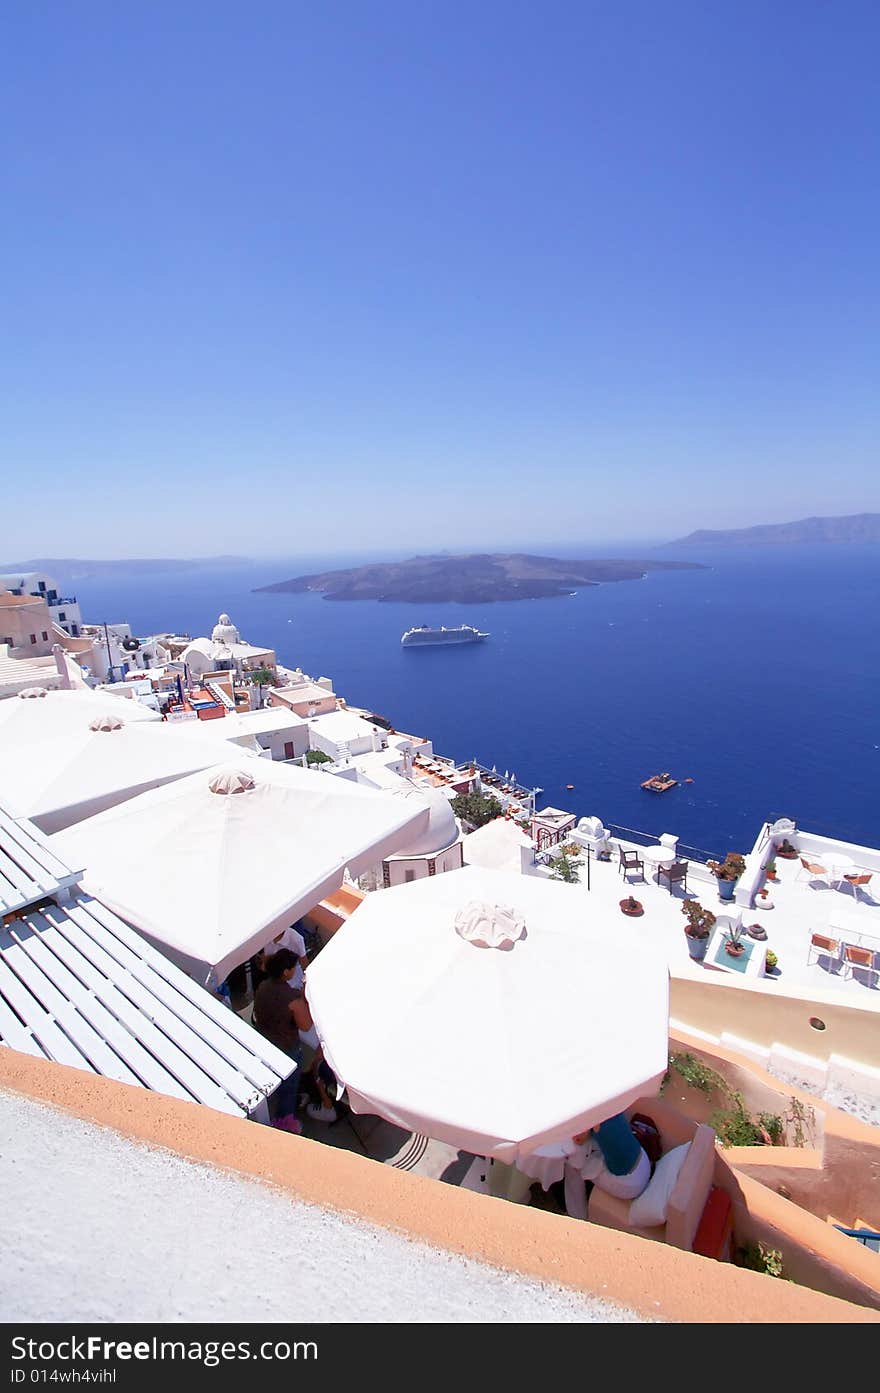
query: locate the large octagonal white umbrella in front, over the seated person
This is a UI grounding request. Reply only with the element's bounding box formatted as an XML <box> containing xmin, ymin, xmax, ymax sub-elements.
<box><xmin>306</xmin><ymin>866</ymin><xmax>668</xmax><ymax>1162</ymax></box>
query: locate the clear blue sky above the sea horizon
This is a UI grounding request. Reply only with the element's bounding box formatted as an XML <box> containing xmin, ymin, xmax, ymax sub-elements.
<box><xmin>0</xmin><ymin>0</ymin><xmax>880</xmax><ymax>560</ymax></box>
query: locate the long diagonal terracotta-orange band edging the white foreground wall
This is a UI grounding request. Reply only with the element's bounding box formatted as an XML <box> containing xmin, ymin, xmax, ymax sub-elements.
<box><xmin>0</xmin><ymin>1049</ymin><xmax>880</xmax><ymax>1325</ymax></box>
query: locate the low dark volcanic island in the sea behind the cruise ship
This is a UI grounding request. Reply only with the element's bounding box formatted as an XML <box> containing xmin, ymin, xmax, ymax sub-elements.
<box><xmin>255</xmin><ymin>553</ymin><xmax>702</xmax><ymax>605</ymax></box>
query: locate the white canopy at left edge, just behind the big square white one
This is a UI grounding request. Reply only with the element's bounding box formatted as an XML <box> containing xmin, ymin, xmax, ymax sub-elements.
<box><xmin>0</xmin><ymin>713</ymin><xmax>217</xmax><ymax>833</ymax></box>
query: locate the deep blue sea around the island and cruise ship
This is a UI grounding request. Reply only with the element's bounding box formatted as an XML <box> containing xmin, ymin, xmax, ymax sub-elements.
<box><xmin>58</xmin><ymin>546</ymin><xmax>880</xmax><ymax>853</ymax></box>
